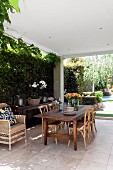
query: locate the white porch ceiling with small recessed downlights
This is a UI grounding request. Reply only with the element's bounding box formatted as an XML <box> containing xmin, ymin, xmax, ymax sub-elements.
<box><xmin>5</xmin><ymin>0</ymin><xmax>113</xmax><ymax>57</ymax></box>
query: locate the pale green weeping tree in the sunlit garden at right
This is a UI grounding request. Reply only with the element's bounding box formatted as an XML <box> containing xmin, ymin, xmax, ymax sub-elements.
<box><xmin>84</xmin><ymin>55</ymin><xmax>113</xmax><ymax>91</ymax></box>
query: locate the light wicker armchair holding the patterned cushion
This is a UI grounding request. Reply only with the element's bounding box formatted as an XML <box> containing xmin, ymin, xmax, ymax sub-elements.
<box><xmin>0</xmin><ymin>115</ymin><xmax>26</xmax><ymax>150</ymax></box>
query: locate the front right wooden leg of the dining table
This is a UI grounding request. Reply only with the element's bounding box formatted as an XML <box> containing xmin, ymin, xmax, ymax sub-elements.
<box><xmin>73</xmin><ymin>120</ymin><xmax>77</xmax><ymax>150</ymax></box>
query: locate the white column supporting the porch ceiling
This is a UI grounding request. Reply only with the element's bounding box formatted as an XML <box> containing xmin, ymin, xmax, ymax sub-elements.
<box><xmin>60</xmin><ymin>57</ymin><xmax>64</xmax><ymax>102</ymax></box>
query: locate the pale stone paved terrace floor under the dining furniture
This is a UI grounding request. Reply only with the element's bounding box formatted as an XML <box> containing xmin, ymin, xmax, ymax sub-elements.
<box><xmin>0</xmin><ymin>120</ymin><xmax>113</xmax><ymax>170</ymax></box>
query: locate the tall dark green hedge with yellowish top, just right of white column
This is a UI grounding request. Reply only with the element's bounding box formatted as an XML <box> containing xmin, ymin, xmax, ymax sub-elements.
<box><xmin>64</xmin><ymin>57</ymin><xmax>84</xmax><ymax>93</ymax></box>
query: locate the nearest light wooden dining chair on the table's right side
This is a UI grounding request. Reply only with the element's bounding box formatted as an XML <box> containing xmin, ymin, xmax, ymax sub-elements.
<box><xmin>68</xmin><ymin>109</ymin><xmax>91</xmax><ymax>149</ymax></box>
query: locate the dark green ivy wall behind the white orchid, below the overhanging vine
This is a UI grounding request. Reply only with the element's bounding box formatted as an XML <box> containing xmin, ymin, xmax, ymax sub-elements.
<box><xmin>0</xmin><ymin>50</ymin><xmax>53</xmax><ymax>103</ymax></box>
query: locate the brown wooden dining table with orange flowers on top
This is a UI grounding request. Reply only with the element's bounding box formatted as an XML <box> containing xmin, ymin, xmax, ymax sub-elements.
<box><xmin>37</xmin><ymin>105</ymin><xmax>93</xmax><ymax>150</ymax></box>
